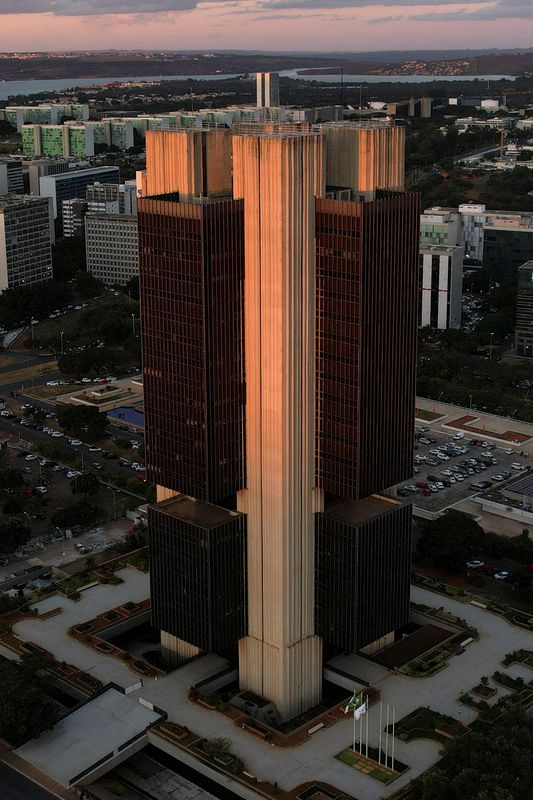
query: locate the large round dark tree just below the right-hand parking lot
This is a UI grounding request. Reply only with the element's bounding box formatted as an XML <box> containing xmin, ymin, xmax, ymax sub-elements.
<box><xmin>417</xmin><ymin>509</ymin><xmax>487</xmax><ymax>572</ymax></box>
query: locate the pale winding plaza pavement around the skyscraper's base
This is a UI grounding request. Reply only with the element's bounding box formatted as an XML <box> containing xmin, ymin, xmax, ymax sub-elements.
<box><xmin>10</xmin><ymin>569</ymin><xmax>533</xmax><ymax>800</ymax></box>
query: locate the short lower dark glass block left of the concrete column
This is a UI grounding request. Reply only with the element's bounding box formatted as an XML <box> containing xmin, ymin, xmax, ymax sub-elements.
<box><xmin>149</xmin><ymin>495</ymin><xmax>246</xmax><ymax>652</ymax></box>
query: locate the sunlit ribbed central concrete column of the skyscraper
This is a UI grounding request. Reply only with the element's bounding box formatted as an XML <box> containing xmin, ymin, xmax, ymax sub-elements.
<box><xmin>233</xmin><ymin>131</ymin><xmax>324</xmax><ymax>719</ymax></box>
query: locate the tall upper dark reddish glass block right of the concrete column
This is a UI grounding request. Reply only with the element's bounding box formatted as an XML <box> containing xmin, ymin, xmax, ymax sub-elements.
<box><xmin>315</xmin><ymin>193</ymin><xmax>420</xmax><ymax>499</ymax></box>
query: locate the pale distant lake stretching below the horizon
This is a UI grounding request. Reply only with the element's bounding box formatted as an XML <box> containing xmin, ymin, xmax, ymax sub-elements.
<box><xmin>0</xmin><ymin>69</ymin><xmax>516</xmax><ymax>100</ymax></box>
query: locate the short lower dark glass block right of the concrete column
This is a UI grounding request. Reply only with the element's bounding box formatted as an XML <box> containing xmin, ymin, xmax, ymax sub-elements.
<box><xmin>315</xmin><ymin>497</ymin><xmax>411</xmax><ymax>653</ymax></box>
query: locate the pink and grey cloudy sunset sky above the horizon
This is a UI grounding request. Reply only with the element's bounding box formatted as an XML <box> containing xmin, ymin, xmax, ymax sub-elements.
<box><xmin>0</xmin><ymin>0</ymin><xmax>533</xmax><ymax>51</ymax></box>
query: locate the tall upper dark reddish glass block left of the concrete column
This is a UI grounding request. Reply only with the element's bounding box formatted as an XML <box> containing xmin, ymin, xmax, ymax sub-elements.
<box><xmin>138</xmin><ymin>196</ymin><xmax>245</xmax><ymax>502</ymax></box>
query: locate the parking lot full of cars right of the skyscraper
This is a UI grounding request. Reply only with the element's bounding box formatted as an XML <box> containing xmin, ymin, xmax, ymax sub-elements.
<box><xmin>398</xmin><ymin>425</ymin><xmax>528</xmax><ymax>513</ymax></box>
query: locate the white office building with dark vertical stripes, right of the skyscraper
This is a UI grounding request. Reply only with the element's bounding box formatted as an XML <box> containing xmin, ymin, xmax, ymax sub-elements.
<box><xmin>419</xmin><ymin>244</ymin><xmax>464</xmax><ymax>330</ymax></box>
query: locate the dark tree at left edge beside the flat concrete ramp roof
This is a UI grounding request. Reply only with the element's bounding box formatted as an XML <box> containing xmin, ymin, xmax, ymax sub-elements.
<box><xmin>0</xmin><ymin>655</ymin><xmax>60</xmax><ymax>747</ymax></box>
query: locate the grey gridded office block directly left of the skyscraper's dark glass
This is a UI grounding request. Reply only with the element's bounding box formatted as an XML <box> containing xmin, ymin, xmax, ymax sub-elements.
<box><xmin>85</xmin><ymin>212</ymin><xmax>139</xmax><ymax>286</ymax></box>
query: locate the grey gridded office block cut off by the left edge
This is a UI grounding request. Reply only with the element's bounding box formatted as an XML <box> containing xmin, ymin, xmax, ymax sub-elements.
<box><xmin>0</xmin><ymin>195</ymin><xmax>54</xmax><ymax>292</ymax></box>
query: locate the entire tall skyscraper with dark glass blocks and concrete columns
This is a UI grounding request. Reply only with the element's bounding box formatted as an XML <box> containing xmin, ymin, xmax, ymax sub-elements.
<box><xmin>138</xmin><ymin>123</ymin><xmax>419</xmax><ymax>719</ymax></box>
